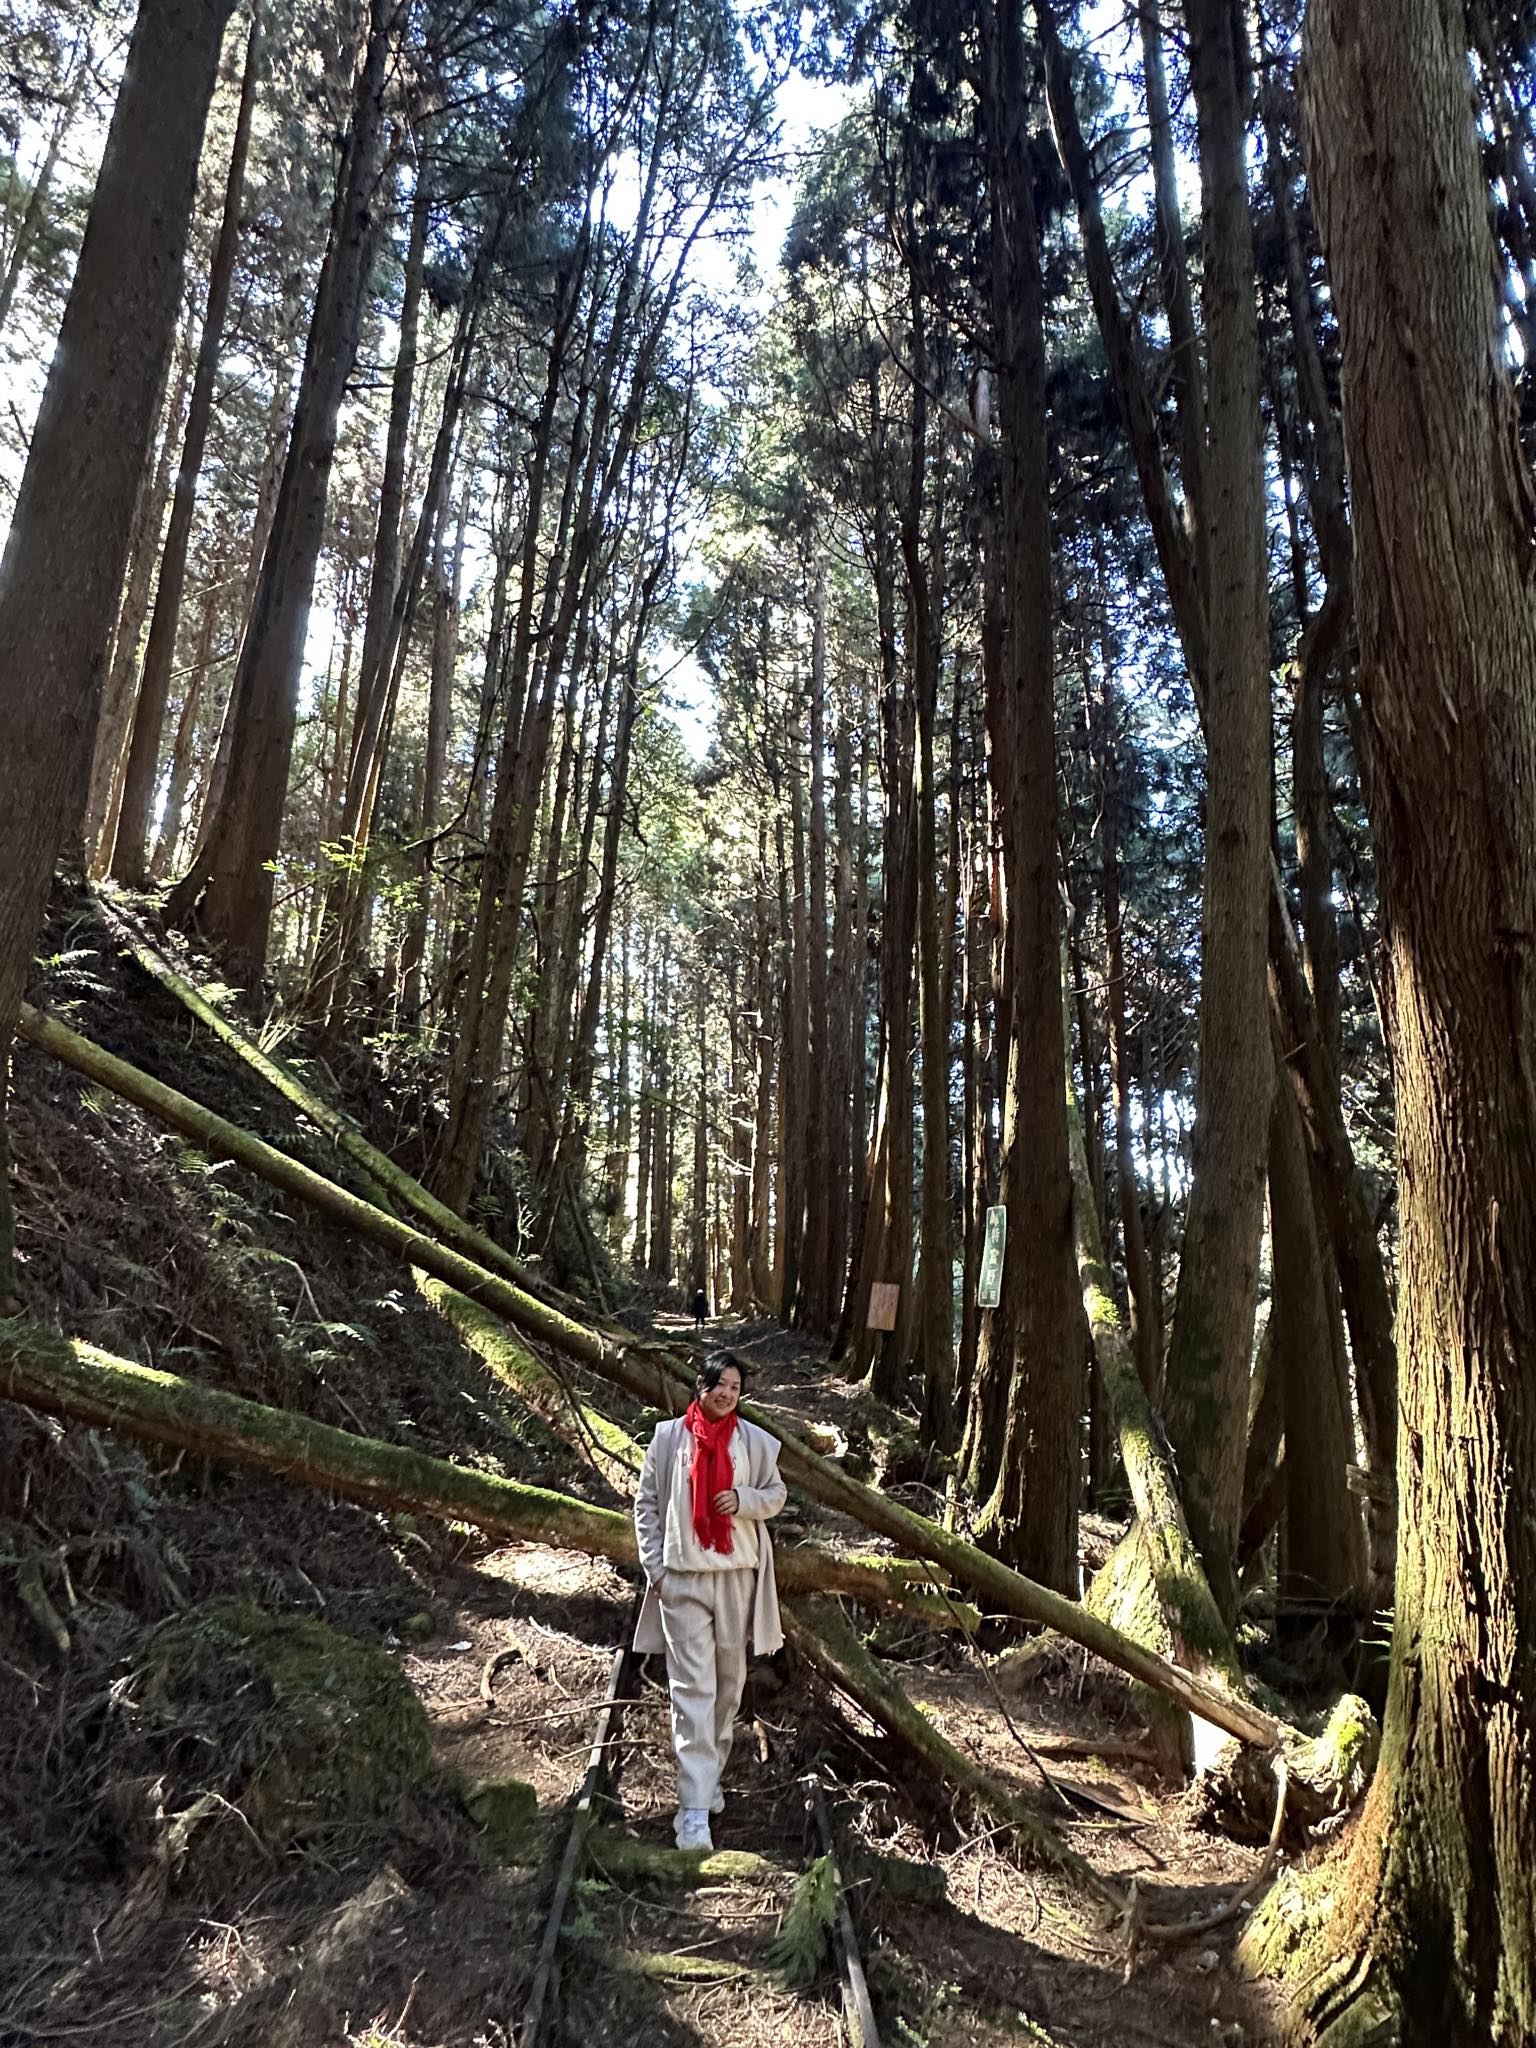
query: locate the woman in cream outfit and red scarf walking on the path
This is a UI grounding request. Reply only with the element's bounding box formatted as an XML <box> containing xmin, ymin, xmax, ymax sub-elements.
<box><xmin>635</xmin><ymin>1358</ymin><xmax>784</xmax><ymax>1849</ymax></box>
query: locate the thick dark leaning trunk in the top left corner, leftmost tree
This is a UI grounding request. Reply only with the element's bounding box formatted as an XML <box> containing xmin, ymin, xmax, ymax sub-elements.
<box><xmin>0</xmin><ymin>0</ymin><xmax>229</xmax><ymax>1313</ymax></box>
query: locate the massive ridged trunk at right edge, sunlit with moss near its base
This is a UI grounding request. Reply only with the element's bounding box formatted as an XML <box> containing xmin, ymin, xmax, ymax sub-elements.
<box><xmin>1277</xmin><ymin>0</ymin><xmax>1536</xmax><ymax>2023</ymax></box>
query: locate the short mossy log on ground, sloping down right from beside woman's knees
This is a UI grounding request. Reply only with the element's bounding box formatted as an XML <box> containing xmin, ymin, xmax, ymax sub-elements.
<box><xmin>784</xmin><ymin>1599</ymin><xmax>1118</xmax><ymax>1905</ymax></box>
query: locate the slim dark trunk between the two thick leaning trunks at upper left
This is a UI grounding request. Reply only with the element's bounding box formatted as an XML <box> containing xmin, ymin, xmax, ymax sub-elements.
<box><xmin>106</xmin><ymin>4</ymin><xmax>262</xmax><ymax>889</ymax></box>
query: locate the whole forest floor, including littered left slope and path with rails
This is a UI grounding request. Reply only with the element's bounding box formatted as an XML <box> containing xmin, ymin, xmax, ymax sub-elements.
<box><xmin>0</xmin><ymin>897</ymin><xmax>1272</xmax><ymax>2048</ymax></box>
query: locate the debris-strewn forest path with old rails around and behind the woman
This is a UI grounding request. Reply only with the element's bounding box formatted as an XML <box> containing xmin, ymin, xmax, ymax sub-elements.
<box><xmin>393</xmin><ymin>1317</ymin><xmax>1268</xmax><ymax>2048</ymax></box>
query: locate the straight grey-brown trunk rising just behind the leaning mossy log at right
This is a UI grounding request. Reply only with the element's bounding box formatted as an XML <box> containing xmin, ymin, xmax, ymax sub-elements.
<box><xmin>1167</xmin><ymin>0</ymin><xmax>1274</xmax><ymax>1622</ymax></box>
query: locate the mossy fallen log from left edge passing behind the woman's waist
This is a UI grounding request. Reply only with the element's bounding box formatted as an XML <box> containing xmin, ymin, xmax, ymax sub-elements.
<box><xmin>0</xmin><ymin>1317</ymin><xmax>974</xmax><ymax>1622</ymax></box>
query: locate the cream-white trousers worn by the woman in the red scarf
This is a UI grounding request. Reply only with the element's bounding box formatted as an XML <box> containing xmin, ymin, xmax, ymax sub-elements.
<box><xmin>659</xmin><ymin>1571</ymin><xmax>758</xmax><ymax>1808</ymax></box>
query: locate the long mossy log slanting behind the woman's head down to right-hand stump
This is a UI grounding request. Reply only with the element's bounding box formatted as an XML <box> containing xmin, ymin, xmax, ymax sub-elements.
<box><xmin>18</xmin><ymin>1004</ymin><xmax>1280</xmax><ymax>1749</ymax></box>
